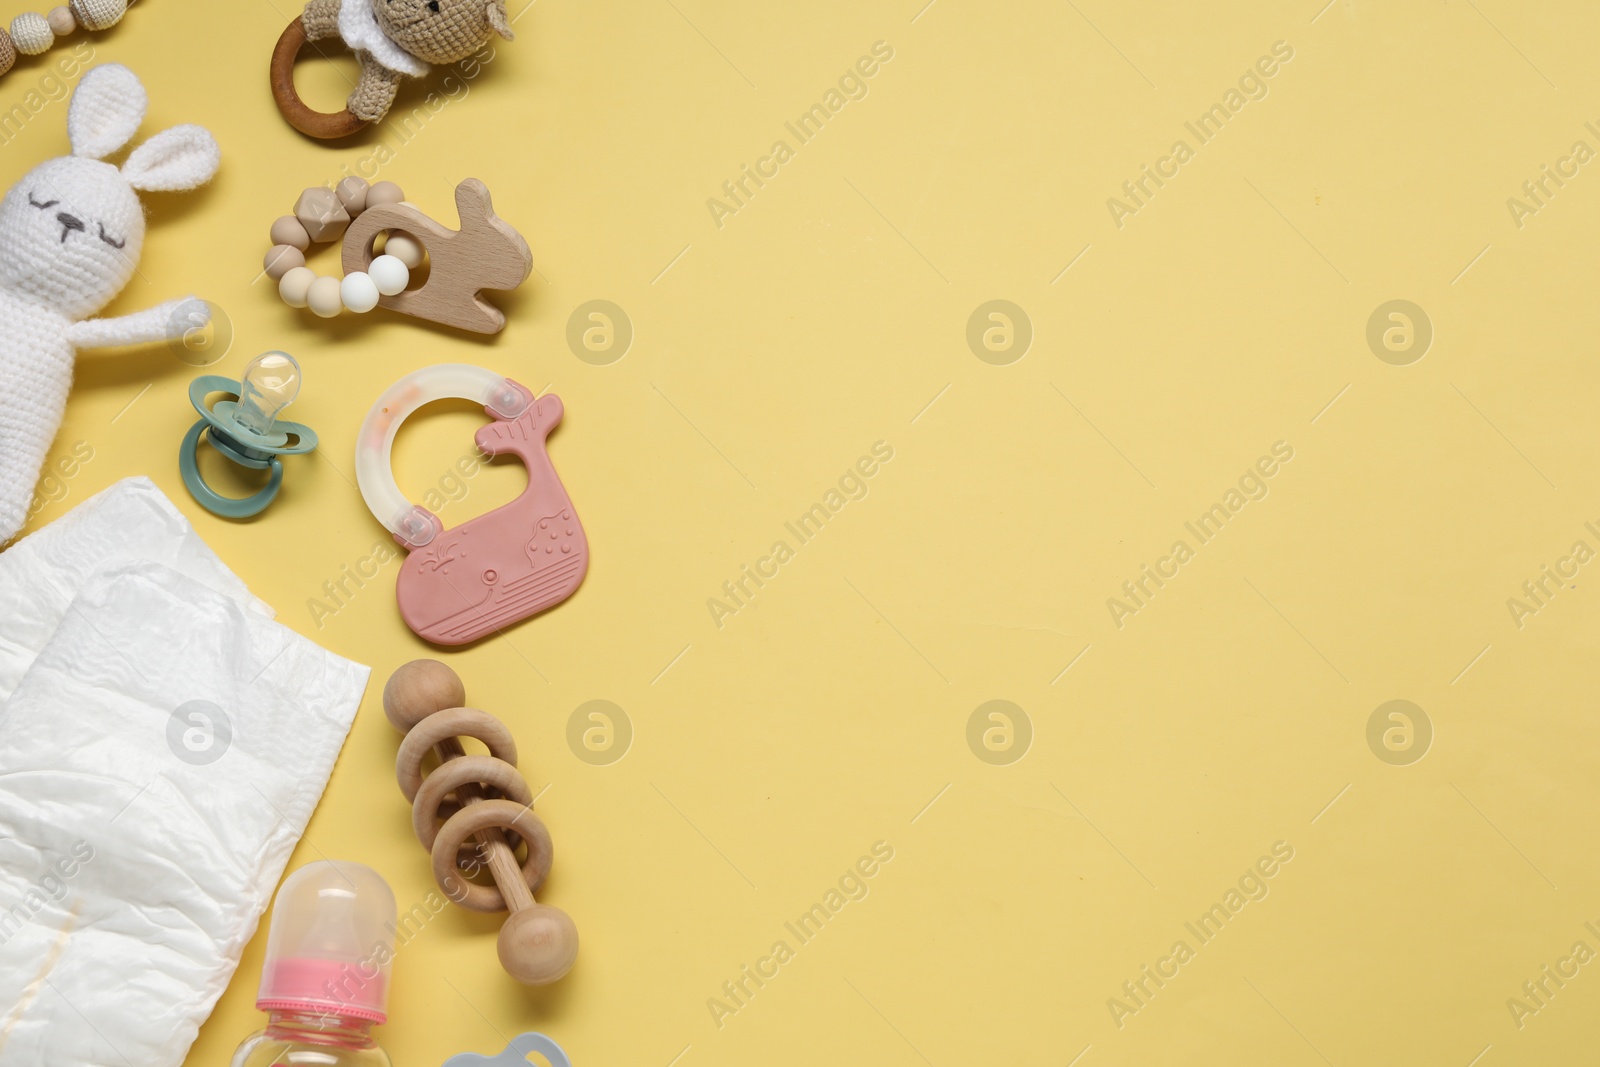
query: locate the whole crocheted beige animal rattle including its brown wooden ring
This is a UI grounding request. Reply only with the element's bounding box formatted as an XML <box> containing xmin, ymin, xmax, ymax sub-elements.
<box><xmin>270</xmin><ymin>0</ymin><xmax>512</xmax><ymax>141</ymax></box>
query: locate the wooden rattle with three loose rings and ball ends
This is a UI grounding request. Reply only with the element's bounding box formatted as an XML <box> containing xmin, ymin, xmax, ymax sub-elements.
<box><xmin>384</xmin><ymin>659</ymin><xmax>578</xmax><ymax>985</ymax></box>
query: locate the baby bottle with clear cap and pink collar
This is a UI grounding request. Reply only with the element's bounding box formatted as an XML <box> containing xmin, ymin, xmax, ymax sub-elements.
<box><xmin>230</xmin><ymin>859</ymin><xmax>395</xmax><ymax>1067</ymax></box>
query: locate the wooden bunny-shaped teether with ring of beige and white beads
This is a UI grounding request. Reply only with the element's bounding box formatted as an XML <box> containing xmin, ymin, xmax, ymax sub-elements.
<box><xmin>262</xmin><ymin>176</ymin><xmax>533</xmax><ymax>333</ymax></box>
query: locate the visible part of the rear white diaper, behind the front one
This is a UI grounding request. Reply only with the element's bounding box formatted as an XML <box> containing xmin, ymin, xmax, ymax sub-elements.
<box><xmin>0</xmin><ymin>478</ymin><xmax>272</xmax><ymax>705</ymax></box>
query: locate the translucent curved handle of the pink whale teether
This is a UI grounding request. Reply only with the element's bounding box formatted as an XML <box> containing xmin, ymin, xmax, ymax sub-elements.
<box><xmin>355</xmin><ymin>363</ymin><xmax>533</xmax><ymax>549</ymax></box>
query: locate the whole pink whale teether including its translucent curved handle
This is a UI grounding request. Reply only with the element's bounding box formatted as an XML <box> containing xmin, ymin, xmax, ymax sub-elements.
<box><xmin>355</xmin><ymin>363</ymin><xmax>589</xmax><ymax>645</ymax></box>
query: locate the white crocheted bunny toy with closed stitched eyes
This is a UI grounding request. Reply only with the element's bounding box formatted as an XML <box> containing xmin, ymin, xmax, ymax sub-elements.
<box><xmin>0</xmin><ymin>64</ymin><xmax>221</xmax><ymax>544</ymax></box>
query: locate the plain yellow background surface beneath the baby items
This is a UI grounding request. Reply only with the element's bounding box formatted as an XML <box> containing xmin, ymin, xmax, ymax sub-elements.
<box><xmin>0</xmin><ymin>0</ymin><xmax>1600</xmax><ymax>1067</ymax></box>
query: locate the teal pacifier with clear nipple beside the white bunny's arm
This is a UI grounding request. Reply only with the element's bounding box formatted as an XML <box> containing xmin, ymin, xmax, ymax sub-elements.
<box><xmin>178</xmin><ymin>352</ymin><xmax>317</xmax><ymax>518</ymax></box>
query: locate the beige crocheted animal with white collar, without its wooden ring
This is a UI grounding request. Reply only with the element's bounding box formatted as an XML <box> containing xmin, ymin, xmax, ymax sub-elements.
<box><xmin>301</xmin><ymin>0</ymin><xmax>512</xmax><ymax>122</ymax></box>
